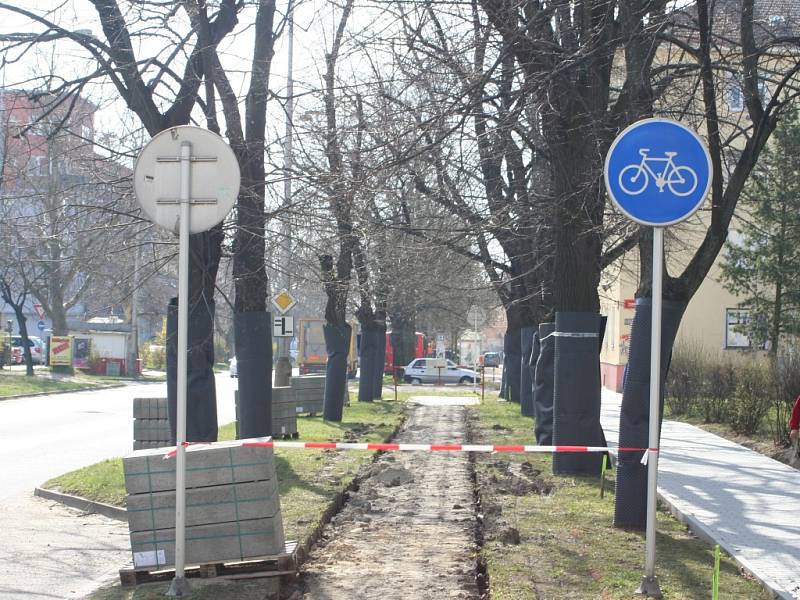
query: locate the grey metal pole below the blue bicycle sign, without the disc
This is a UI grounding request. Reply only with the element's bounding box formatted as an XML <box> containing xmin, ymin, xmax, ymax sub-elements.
<box><xmin>641</xmin><ymin>227</ymin><xmax>664</xmax><ymax>598</ymax></box>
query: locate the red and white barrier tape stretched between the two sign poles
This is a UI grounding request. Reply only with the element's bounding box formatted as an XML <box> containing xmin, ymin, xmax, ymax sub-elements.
<box><xmin>164</xmin><ymin>440</ymin><xmax>658</xmax><ymax>465</ymax></box>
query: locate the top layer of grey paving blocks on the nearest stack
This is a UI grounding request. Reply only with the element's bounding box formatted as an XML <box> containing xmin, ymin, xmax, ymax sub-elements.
<box><xmin>122</xmin><ymin>437</ymin><xmax>275</xmax><ymax>494</ymax></box>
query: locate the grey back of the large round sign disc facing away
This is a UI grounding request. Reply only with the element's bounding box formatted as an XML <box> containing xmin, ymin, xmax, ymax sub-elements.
<box><xmin>133</xmin><ymin>125</ymin><xmax>240</xmax><ymax>233</ymax></box>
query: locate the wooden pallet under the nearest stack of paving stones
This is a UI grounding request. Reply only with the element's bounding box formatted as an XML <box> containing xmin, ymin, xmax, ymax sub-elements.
<box><xmin>119</xmin><ymin>542</ymin><xmax>298</xmax><ymax>587</ymax></box>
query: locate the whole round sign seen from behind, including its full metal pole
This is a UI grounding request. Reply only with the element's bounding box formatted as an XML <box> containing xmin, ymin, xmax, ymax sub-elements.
<box><xmin>133</xmin><ymin>126</ymin><xmax>240</xmax><ymax>596</ymax></box>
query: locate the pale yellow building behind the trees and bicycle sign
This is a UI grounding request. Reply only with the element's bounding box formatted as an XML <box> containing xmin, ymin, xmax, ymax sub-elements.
<box><xmin>598</xmin><ymin>0</ymin><xmax>800</xmax><ymax>391</ymax></box>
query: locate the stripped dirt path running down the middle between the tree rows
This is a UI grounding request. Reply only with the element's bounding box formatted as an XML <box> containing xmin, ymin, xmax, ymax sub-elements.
<box><xmin>296</xmin><ymin>397</ymin><xmax>479</xmax><ymax>600</ymax></box>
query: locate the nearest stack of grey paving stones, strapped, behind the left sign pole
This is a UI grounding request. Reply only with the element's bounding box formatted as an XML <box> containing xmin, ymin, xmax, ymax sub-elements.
<box><xmin>123</xmin><ymin>438</ymin><xmax>285</xmax><ymax>570</ymax></box>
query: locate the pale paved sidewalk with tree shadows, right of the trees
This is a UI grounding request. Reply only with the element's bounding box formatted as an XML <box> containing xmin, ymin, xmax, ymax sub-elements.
<box><xmin>601</xmin><ymin>390</ymin><xmax>800</xmax><ymax>599</ymax></box>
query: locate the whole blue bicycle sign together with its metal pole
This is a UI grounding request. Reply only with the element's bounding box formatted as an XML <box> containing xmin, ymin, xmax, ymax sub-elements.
<box><xmin>604</xmin><ymin>119</ymin><xmax>713</xmax><ymax>598</ymax></box>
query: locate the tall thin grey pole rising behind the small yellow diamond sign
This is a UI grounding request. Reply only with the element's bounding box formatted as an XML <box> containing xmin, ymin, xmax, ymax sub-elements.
<box><xmin>275</xmin><ymin>11</ymin><xmax>294</xmax><ymax>387</ymax></box>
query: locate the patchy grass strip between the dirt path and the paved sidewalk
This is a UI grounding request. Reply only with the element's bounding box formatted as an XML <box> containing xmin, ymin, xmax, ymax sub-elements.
<box><xmin>473</xmin><ymin>399</ymin><xmax>771</xmax><ymax>600</ymax></box>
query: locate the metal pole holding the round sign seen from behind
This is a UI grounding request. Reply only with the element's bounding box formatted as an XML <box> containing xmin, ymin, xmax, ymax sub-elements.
<box><xmin>168</xmin><ymin>141</ymin><xmax>192</xmax><ymax>596</ymax></box>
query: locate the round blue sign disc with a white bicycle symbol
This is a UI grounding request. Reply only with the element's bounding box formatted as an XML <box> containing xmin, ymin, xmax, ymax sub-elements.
<box><xmin>604</xmin><ymin>119</ymin><xmax>712</xmax><ymax>227</ymax></box>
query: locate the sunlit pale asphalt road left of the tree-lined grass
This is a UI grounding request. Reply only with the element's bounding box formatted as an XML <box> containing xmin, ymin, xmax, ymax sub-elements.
<box><xmin>0</xmin><ymin>372</ymin><xmax>237</xmax><ymax>600</ymax></box>
